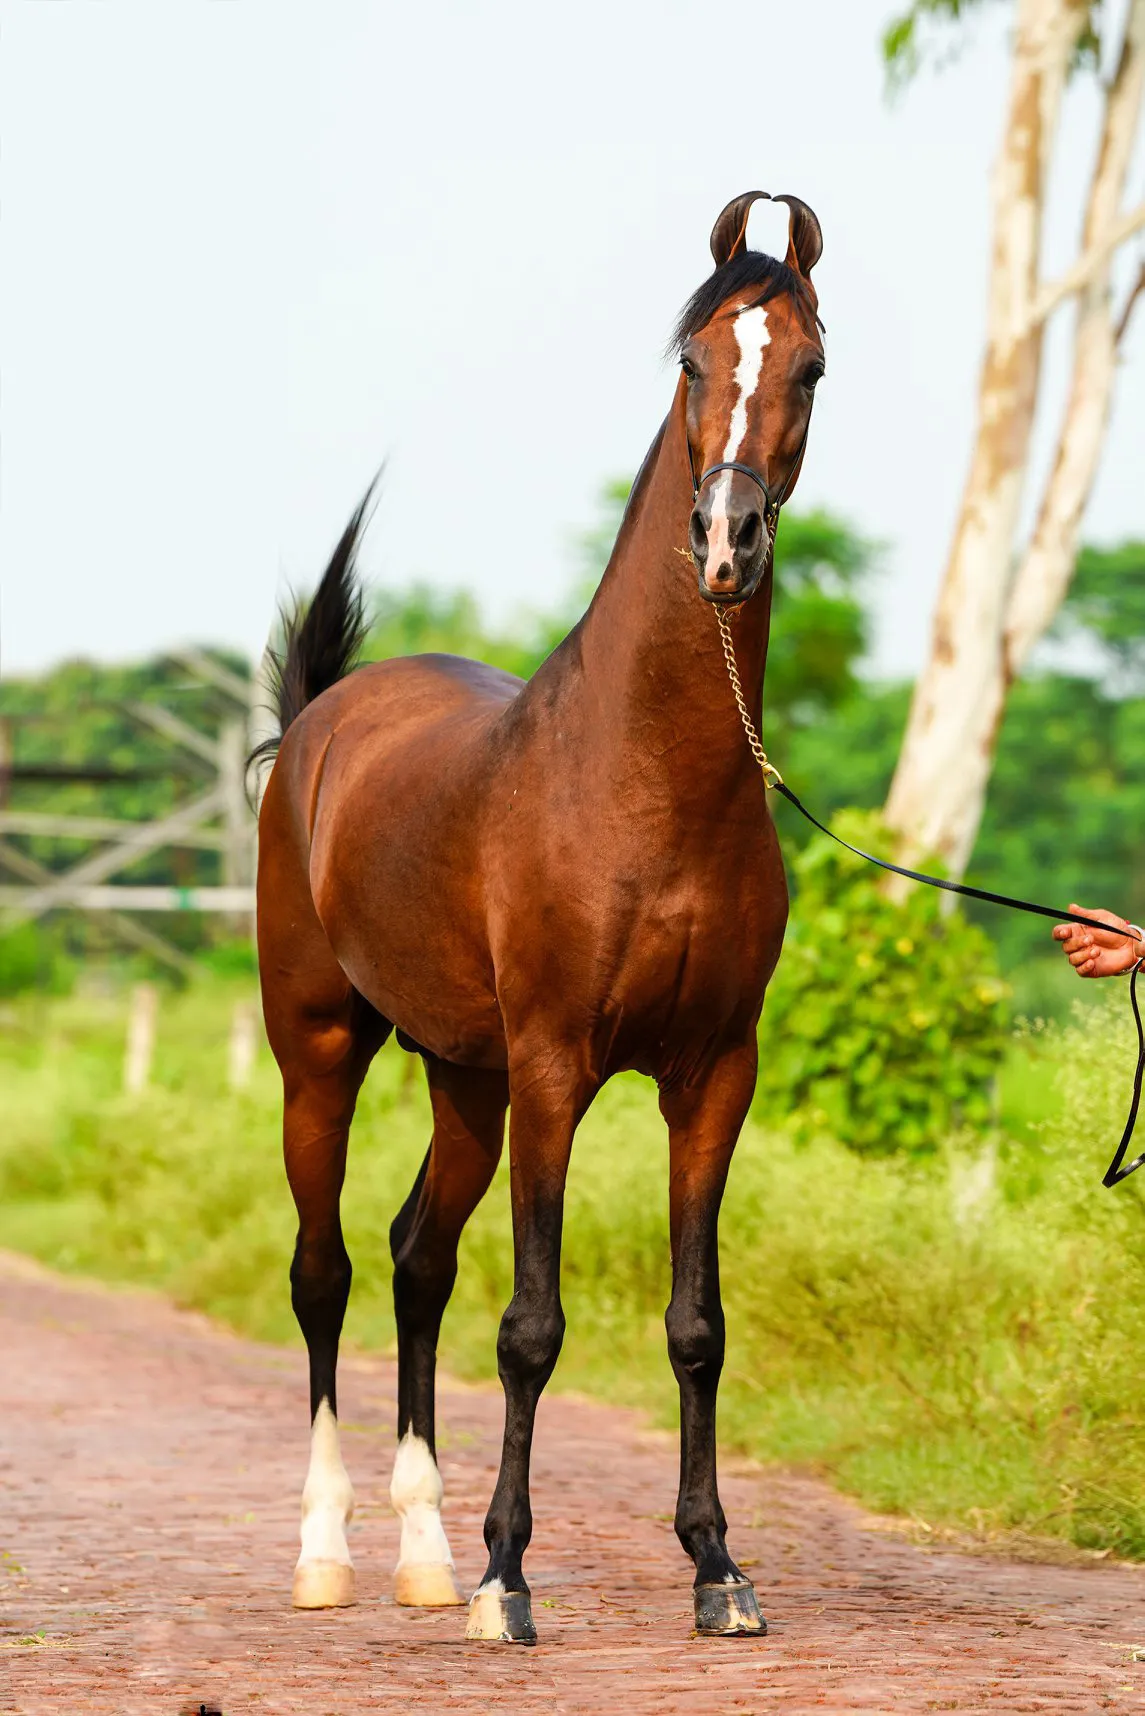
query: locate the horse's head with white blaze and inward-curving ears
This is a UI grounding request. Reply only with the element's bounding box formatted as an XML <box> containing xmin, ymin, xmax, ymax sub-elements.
<box><xmin>673</xmin><ymin>190</ymin><xmax>824</xmax><ymax>602</ymax></box>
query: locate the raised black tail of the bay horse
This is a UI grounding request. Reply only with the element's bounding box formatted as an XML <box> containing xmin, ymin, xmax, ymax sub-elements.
<box><xmin>251</xmin><ymin>472</ymin><xmax>381</xmax><ymax>762</ymax></box>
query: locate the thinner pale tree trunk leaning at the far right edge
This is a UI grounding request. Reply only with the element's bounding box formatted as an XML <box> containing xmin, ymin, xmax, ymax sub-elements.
<box><xmin>1001</xmin><ymin>0</ymin><xmax>1145</xmax><ymax>676</ymax></box>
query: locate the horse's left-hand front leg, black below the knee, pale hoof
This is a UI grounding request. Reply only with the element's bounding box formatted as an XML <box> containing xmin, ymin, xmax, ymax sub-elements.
<box><xmin>465</xmin><ymin>1066</ymin><xmax>589</xmax><ymax>1644</ymax></box>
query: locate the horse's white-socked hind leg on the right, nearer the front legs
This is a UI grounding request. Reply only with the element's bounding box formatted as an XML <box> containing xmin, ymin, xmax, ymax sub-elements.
<box><xmin>390</xmin><ymin>1055</ymin><xmax>508</xmax><ymax>1608</ymax></box>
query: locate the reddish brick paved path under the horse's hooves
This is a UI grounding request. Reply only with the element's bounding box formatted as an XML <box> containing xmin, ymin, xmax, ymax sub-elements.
<box><xmin>0</xmin><ymin>1258</ymin><xmax>1145</xmax><ymax>1716</ymax></box>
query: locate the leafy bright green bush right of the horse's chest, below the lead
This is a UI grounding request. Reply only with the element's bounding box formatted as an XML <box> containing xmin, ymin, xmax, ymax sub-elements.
<box><xmin>755</xmin><ymin>810</ymin><xmax>1008</xmax><ymax>1153</ymax></box>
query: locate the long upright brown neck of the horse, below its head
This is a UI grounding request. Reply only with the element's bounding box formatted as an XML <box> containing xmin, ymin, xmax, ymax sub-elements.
<box><xmin>579</xmin><ymin>393</ymin><xmax>771</xmax><ymax>798</ymax></box>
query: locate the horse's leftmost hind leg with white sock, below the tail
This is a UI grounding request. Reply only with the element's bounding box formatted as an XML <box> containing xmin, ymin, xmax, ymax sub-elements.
<box><xmin>259</xmin><ymin>909</ymin><xmax>390</xmax><ymax>1608</ymax></box>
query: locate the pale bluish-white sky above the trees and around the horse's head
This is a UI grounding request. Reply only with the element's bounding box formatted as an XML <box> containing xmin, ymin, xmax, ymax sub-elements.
<box><xmin>0</xmin><ymin>0</ymin><xmax>1145</xmax><ymax>674</ymax></box>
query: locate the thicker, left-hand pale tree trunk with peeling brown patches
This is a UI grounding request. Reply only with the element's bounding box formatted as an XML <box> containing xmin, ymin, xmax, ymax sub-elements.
<box><xmin>886</xmin><ymin>0</ymin><xmax>1087</xmax><ymax>873</ymax></box>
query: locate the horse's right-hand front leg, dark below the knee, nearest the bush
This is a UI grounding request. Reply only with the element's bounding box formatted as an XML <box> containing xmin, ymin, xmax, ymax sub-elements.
<box><xmin>659</xmin><ymin>1040</ymin><xmax>767</xmax><ymax>1635</ymax></box>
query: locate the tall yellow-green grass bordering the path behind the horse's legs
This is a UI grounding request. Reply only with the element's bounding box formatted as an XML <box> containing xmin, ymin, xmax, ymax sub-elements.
<box><xmin>0</xmin><ymin>982</ymin><xmax>1145</xmax><ymax>1556</ymax></box>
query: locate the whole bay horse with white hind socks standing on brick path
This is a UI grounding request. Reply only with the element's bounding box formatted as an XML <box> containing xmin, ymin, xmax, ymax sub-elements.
<box><xmin>257</xmin><ymin>190</ymin><xmax>824</xmax><ymax>1644</ymax></box>
